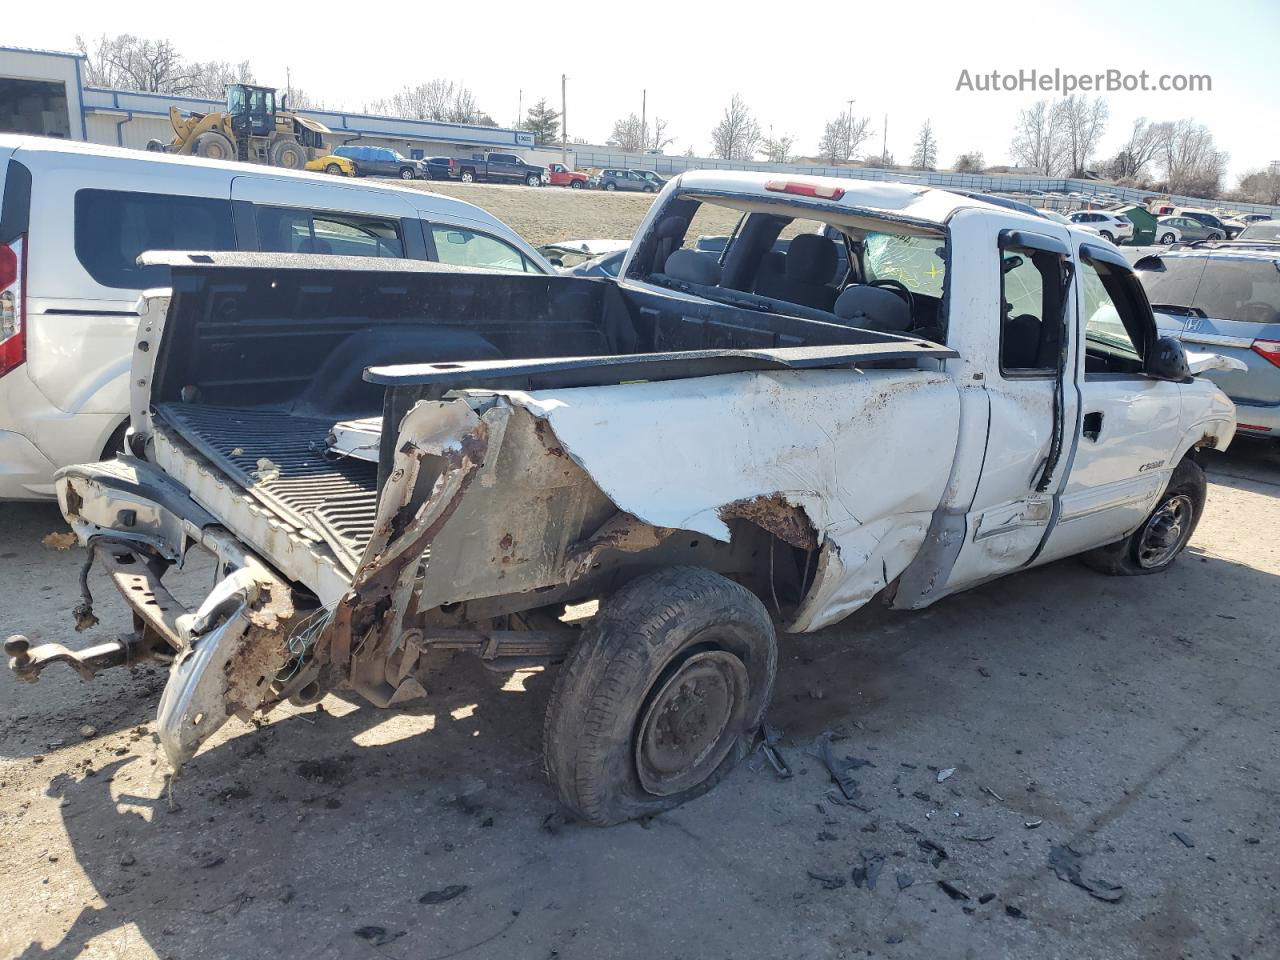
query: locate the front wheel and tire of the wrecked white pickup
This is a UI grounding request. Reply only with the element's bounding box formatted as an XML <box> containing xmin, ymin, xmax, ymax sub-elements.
<box><xmin>1080</xmin><ymin>457</ymin><xmax>1207</xmax><ymax>576</ymax></box>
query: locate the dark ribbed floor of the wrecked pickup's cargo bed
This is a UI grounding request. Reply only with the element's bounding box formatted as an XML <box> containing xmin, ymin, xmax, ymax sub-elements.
<box><xmin>157</xmin><ymin>403</ymin><xmax>378</xmax><ymax>570</ymax></box>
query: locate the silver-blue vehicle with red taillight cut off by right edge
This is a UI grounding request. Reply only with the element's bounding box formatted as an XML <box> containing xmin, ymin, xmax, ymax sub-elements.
<box><xmin>1134</xmin><ymin>244</ymin><xmax>1280</xmax><ymax>439</ymax></box>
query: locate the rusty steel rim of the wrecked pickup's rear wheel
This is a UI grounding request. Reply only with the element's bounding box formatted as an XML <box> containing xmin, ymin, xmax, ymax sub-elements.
<box><xmin>635</xmin><ymin>649</ymin><xmax>750</xmax><ymax>796</ymax></box>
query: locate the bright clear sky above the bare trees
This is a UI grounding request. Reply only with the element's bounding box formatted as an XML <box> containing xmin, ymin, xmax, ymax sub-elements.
<box><xmin>12</xmin><ymin>0</ymin><xmax>1280</xmax><ymax>186</ymax></box>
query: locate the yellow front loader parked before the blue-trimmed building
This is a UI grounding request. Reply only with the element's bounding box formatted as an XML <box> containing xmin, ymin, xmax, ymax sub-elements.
<box><xmin>147</xmin><ymin>83</ymin><xmax>330</xmax><ymax>170</ymax></box>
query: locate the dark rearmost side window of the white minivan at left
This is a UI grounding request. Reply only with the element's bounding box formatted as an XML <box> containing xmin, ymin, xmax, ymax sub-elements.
<box><xmin>76</xmin><ymin>189</ymin><xmax>236</xmax><ymax>291</ymax></box>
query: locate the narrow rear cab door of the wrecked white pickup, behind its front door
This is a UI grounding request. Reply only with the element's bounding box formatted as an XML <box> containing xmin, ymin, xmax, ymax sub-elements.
<box><xmin>938</xmin><ymin>218</ymin><xmax>1078</xmax><ymax>595</ymax></box>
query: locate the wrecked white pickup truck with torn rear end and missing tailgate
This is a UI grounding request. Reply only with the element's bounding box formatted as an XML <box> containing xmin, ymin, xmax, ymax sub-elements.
<box><xmin>6</xmin><ymin>173</ymin><xmax>1234</xmax><ymax>823</ymax></box>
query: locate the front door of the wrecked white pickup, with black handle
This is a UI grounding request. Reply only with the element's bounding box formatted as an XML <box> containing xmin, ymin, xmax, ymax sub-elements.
<box><xmin>1036</xmin><ymin>243</ymin><xmax>1183</xmax><ymax>563</ymax></box>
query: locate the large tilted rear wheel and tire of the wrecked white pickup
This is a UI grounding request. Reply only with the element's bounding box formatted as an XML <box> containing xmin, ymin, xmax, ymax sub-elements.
<box><xmin>543</xmin><ymin>567</ymin><xmax>777</xmax><ymax>827</ymax></box>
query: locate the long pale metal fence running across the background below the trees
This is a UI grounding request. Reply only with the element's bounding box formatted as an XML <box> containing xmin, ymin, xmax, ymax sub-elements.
<box><xmin>575</xmin><ymin>146</ymin><xmax>1280</xmax><ymax>218</ymax></box>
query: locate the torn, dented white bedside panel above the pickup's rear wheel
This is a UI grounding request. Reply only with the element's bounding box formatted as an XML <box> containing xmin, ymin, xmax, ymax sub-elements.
<box><xmin>484</xmin><ymin>370</ymin><xmax>959</xmax><ymax>631</ymax></box>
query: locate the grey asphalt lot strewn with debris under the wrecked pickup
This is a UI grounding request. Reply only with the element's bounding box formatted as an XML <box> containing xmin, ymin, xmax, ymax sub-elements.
<box><xmin>0</xmin><ymin>443</ymin><xmax>1280</xmax><ymax>960</ymax></box>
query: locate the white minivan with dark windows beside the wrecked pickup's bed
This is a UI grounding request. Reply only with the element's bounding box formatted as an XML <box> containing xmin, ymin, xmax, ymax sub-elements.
<box><xmin>0</xmin><ymin>134</ymin><xmax>554</xmax><ymax>499</ymax></box>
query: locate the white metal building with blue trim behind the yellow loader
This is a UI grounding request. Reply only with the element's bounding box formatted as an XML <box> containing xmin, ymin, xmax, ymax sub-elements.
<box><xmin>0</xmin><ymin>46</ymin><xmax>545</xmax><ymax>161</ymax></box>
